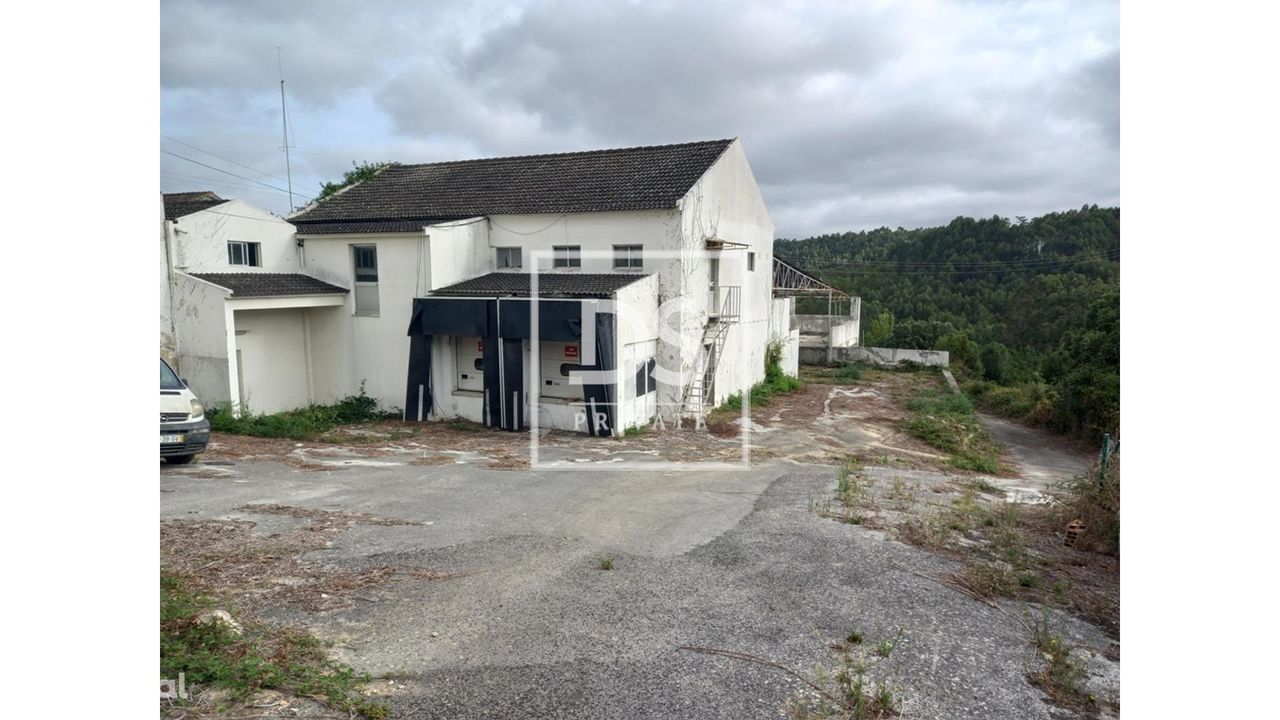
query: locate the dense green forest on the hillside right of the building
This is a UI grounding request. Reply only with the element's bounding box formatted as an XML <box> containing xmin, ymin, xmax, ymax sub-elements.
<box><xmin>774</xmin><ymin>205</ymin><xmax>1120</xmax><ymax>438</ymax></box>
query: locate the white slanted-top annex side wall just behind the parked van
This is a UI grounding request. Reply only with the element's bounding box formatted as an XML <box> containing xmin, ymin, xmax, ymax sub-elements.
<box><xmin>173</xmin><ymin>273</ymin><xmax>236</xmax><ymax>406</ymax></box>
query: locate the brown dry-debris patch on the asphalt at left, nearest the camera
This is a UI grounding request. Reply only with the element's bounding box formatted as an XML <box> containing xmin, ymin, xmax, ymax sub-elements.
<box><xmin>160</xmin><ymin>505</ymin><xmax>456</xmax><ymax>612</ymax></box>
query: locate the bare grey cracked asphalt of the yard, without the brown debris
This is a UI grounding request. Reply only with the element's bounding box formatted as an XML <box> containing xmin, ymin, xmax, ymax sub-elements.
<box><xmin>160</xmin><ymin>450</ymin><xmax>1108</xmax><ymax>719</ymax></box>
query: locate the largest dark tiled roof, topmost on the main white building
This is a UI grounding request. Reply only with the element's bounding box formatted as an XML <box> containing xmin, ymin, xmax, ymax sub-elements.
<box><xmin>289</xmin><ymin>140</ymin><xmax>733</xmax><ymax>232</ymax></box>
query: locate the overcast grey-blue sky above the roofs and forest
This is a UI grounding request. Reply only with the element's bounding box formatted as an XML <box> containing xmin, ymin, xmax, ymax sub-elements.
<box><xmin>157</xmin><ymin>0</ymin><xmax>1120</xmax><ymax>237</ymax></box>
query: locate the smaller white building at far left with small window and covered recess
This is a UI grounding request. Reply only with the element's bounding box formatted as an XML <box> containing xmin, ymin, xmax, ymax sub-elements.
<box><xmin>160</xmin><ymin>192</ymin><xmax>348</xmax><ymax>413</ymax></box>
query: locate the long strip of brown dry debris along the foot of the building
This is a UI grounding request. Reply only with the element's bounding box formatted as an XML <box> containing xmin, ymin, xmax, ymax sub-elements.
<box><xmin>205</xmin><ymin>368</ymin><xmax>988</xmax><ymax>470</ymax></box>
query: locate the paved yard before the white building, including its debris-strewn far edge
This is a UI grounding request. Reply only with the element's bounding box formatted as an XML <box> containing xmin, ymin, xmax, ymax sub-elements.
<box><xmin>160</xmin><ymin>373</ymin><xmax>1119</xmax><ymax>719</ymax></box>
